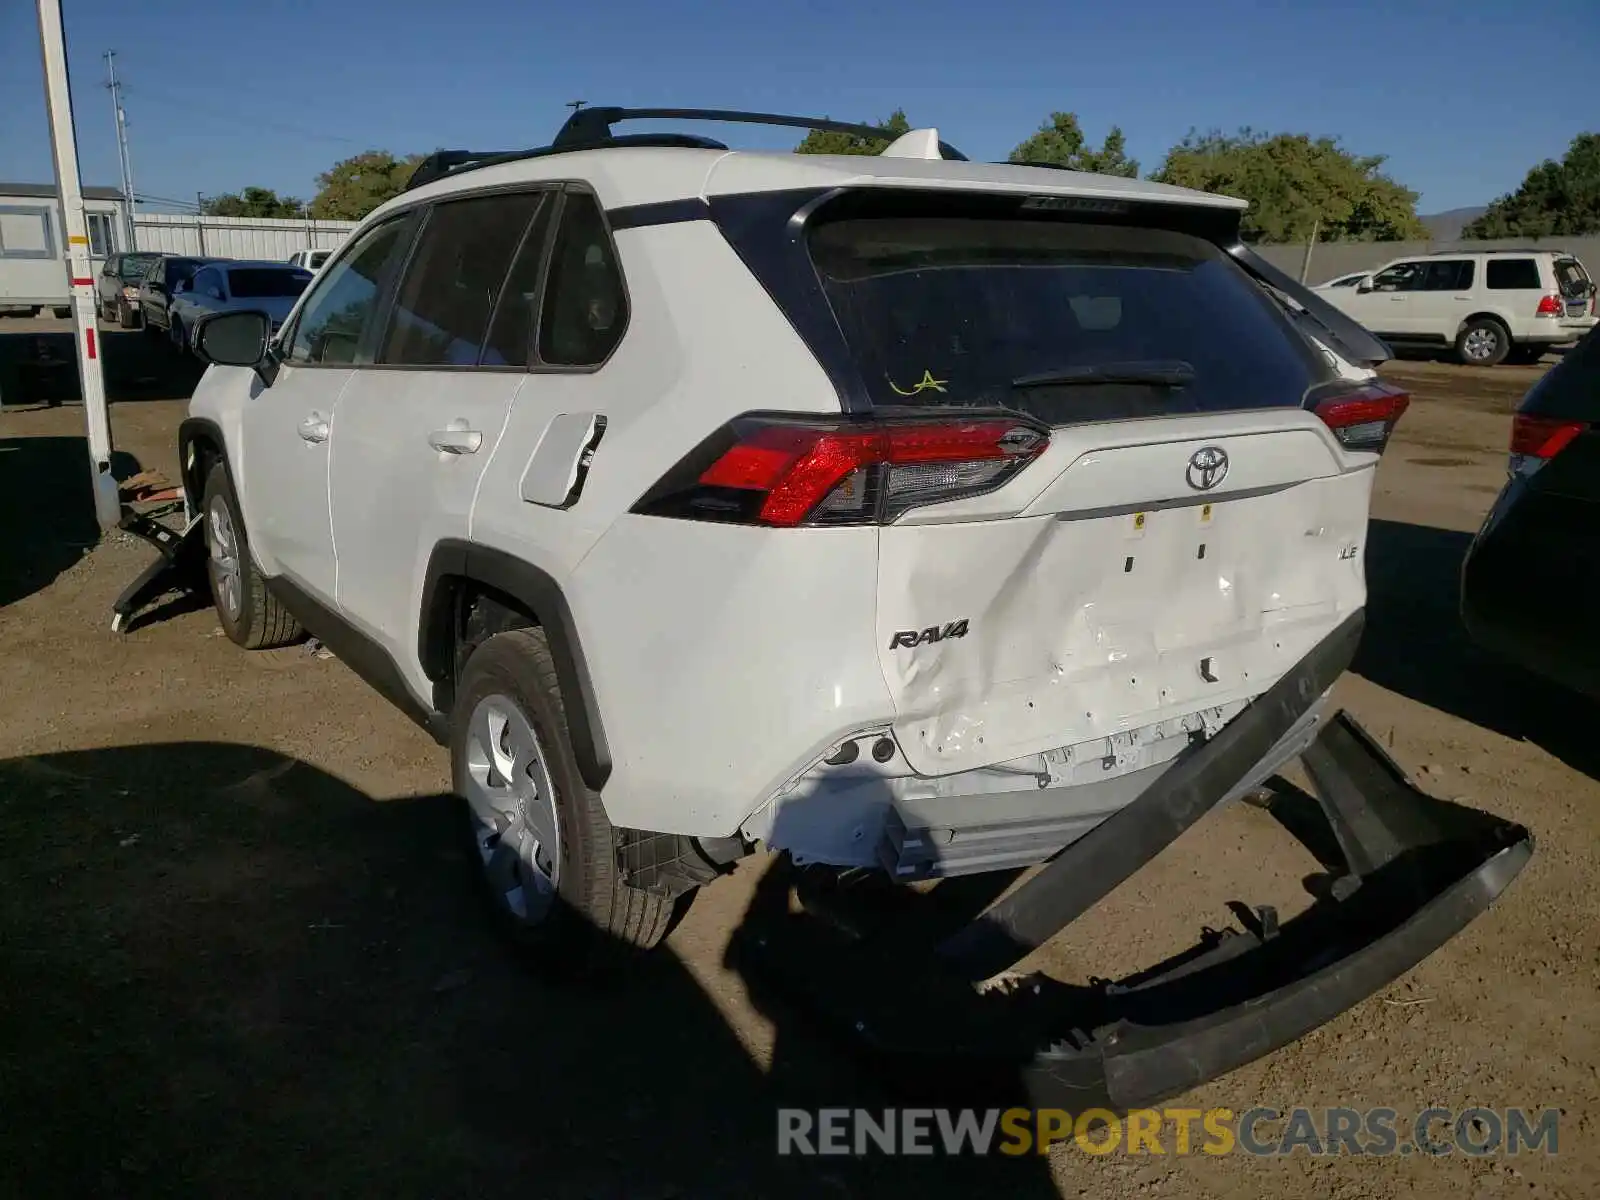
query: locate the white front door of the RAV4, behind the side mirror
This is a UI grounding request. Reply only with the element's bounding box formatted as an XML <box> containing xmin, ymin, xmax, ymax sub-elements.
<box><xmin>238</xmin><ymin>218</ymin><xmax>411</xmax><ymax>608</ymax></box>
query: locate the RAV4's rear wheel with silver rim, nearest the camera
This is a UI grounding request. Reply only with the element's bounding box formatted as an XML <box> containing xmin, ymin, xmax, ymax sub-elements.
<box><xmin>450</xmin><ymin>629</ymin><xmax>675</xmax><ymax>971</ymax></box>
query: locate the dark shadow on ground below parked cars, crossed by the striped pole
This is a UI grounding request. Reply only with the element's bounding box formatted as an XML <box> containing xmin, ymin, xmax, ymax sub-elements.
<box><xmin>0</xmin><ymin>326</ymin><xmax>205</xmax><ymax>406</ymax></box>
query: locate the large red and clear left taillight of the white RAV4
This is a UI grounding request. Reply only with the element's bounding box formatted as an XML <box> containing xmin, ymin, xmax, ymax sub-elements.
<box><xmin>634</xmin><ymin>414</ymin><xmax>1050</xmax><ymax>526</ymax></box>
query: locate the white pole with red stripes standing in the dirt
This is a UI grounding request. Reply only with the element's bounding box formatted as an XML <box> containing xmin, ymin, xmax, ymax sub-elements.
<box><xmin>38</xmin><ymin>0</ymin><xmax>122</xmax><ymax>530</ymax></box>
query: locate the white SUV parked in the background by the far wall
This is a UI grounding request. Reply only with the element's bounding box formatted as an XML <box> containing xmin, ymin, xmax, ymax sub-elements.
<box><xmin>1318</xmin><ymin>250</ymin><xmax>1595</xmax><ymax>366</ymax></box>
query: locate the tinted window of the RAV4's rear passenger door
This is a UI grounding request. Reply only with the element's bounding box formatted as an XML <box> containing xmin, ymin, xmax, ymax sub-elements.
<box><xmin>378</xmin><ymin>192</ymin><xmax>546</xmax><ymax>366</ymax></box>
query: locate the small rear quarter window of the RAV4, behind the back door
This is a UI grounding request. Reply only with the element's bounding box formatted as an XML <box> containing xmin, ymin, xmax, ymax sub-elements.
<box><xmin>539</xmin><ymin>192</ymin><xmax>627</xmax><ymax>366</ymax></box>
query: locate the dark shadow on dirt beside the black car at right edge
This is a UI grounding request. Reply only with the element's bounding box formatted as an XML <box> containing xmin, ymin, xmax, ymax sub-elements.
<box><xmin>1352</xmin><ymin>520</ymin><xmax>1600</xmax><ymax>779</ymax></box>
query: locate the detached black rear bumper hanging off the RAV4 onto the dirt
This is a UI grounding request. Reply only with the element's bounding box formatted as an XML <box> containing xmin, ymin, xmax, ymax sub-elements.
<box><xmin>730</xmin><ymin>614</ymin><xmax>1533</xmax><ymax>1112</ymax></box>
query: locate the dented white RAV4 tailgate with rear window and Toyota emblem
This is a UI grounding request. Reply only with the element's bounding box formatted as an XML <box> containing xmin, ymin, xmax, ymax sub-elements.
<box><xmin>811</xmin><ymin>209</ymin><xmax>1382</xmax><ymax>774</ymax></box>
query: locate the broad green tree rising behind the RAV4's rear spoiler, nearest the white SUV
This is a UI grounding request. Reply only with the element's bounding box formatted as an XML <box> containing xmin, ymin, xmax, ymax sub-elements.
<box><xmin>1150</xmin><ymin>130</ymin><xmax>1427</xmax><ymax>242</ymax></box>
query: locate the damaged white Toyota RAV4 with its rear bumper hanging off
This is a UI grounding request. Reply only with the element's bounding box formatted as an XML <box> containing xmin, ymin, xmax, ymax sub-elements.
<box><xmin>172</xmin><ymin>109</ymin><xmax>1528</xmax><ymax>1101</ymax></box>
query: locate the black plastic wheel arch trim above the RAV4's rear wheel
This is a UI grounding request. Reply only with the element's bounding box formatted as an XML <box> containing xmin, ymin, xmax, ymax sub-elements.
<box><xmin>418</xmin><ymin>539</ymin><xmax>611</xmax><ymax>792</ymax></box>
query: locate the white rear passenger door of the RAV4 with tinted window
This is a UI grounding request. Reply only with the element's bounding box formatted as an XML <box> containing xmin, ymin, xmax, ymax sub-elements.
<box><xmin>333</xmin><ymin>190</ymin><xmax>555</xmax><ymax>698</ymax></box>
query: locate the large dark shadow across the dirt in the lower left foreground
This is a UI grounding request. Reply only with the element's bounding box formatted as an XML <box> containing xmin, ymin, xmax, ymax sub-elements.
<box><xmin>0</xmin><ymin>744</ymin><xmax>1056</xmax><ymax>1200</ymax></box>
